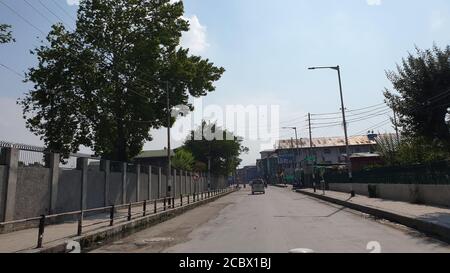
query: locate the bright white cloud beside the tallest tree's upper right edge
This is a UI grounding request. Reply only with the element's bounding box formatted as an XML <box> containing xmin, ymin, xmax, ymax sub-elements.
<box><xmin>181</xmin><ymin>15</ymin><xmax>209</xmax><ymax>54</ymax></box>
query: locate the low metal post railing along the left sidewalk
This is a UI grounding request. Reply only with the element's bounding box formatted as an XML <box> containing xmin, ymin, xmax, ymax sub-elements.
<box><xmin>0</xmin><ymin>188</ymin><xmax>233</xmax><ymax>248</ymax></box>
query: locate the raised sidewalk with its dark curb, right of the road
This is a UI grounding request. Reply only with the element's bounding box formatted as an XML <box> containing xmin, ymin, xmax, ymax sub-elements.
<box><xmin>297</xmin><ymin>189</ymin><xmax>450</xmax><ymax>242</ymax></box>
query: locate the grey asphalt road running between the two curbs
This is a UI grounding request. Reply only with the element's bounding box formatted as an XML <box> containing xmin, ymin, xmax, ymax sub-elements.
<box><xmin>94</xmin><ymin>187</ymin><xmax>450</xmax><ymax>253</ymax></box>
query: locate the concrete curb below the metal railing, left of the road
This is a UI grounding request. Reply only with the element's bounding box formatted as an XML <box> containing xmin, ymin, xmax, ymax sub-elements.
<box><xmin>19</xmin><ymin>189</ymin><xmax>238</xmax><ymax>253</ymax></box>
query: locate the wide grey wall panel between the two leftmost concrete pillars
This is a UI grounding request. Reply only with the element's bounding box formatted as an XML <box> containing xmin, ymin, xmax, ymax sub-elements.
<box><xmin>14</xmin><ymin>167</ymin><xmax>50</xmax><ymax>220</ymax></box>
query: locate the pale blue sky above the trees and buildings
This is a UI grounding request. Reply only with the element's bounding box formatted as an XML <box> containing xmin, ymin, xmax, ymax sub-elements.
<box><xmin>0</xmin><ymin>0</ymin><xmax>450</xmax><ymax>164</ymax></box>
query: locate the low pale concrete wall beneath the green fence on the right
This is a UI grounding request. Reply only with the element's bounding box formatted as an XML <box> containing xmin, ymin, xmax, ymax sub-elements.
<box><xmin>329</xmin><ymin>183</ymin><xmax>450</xmax><ymax>207</ymax></box>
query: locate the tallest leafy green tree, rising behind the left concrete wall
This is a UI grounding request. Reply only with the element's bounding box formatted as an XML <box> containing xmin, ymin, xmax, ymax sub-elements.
<box><xmin>19</xmin><ymin>0</ymin><xmax>224</xmax><ymax>161</ymax></box>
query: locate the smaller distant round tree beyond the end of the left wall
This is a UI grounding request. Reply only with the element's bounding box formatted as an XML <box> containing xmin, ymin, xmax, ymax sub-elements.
<box><xmin>183</xmin><ymin>122</ymin><xmax>249</xmax><ymax>175</ymax></box>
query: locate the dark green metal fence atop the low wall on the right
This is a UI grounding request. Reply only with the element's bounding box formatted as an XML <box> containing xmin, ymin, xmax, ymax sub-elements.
<box><xmin>324</xmin><ymin>162</ymin><xmax>450</xmax><ymax>185</ymax></box>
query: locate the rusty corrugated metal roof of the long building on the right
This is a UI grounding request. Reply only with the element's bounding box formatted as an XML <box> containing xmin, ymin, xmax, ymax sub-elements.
<box><xmin>278</xmin><ymin>136</ymin><xmax>376</xmax><ymax>149</ymax></box>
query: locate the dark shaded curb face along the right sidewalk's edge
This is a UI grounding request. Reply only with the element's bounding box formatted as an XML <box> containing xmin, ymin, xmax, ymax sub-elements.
<box><xmin>296</xmin><ymin>190</ymin><xmax>450</xmax><ymax>243</ymax></box>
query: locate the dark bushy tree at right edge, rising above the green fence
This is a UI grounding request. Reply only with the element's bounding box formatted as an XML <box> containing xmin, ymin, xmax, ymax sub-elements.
<box><xmin>384</xmin><ymin>46</ymin><xmax>450</xmax><ymax>151</ymax></box>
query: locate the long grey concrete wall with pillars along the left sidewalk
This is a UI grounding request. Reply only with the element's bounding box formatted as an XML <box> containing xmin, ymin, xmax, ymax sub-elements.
<box><xmin>0</xmin><ymin>151</ymin><xmax>226</xmax><ymax>220</ymax></box>
